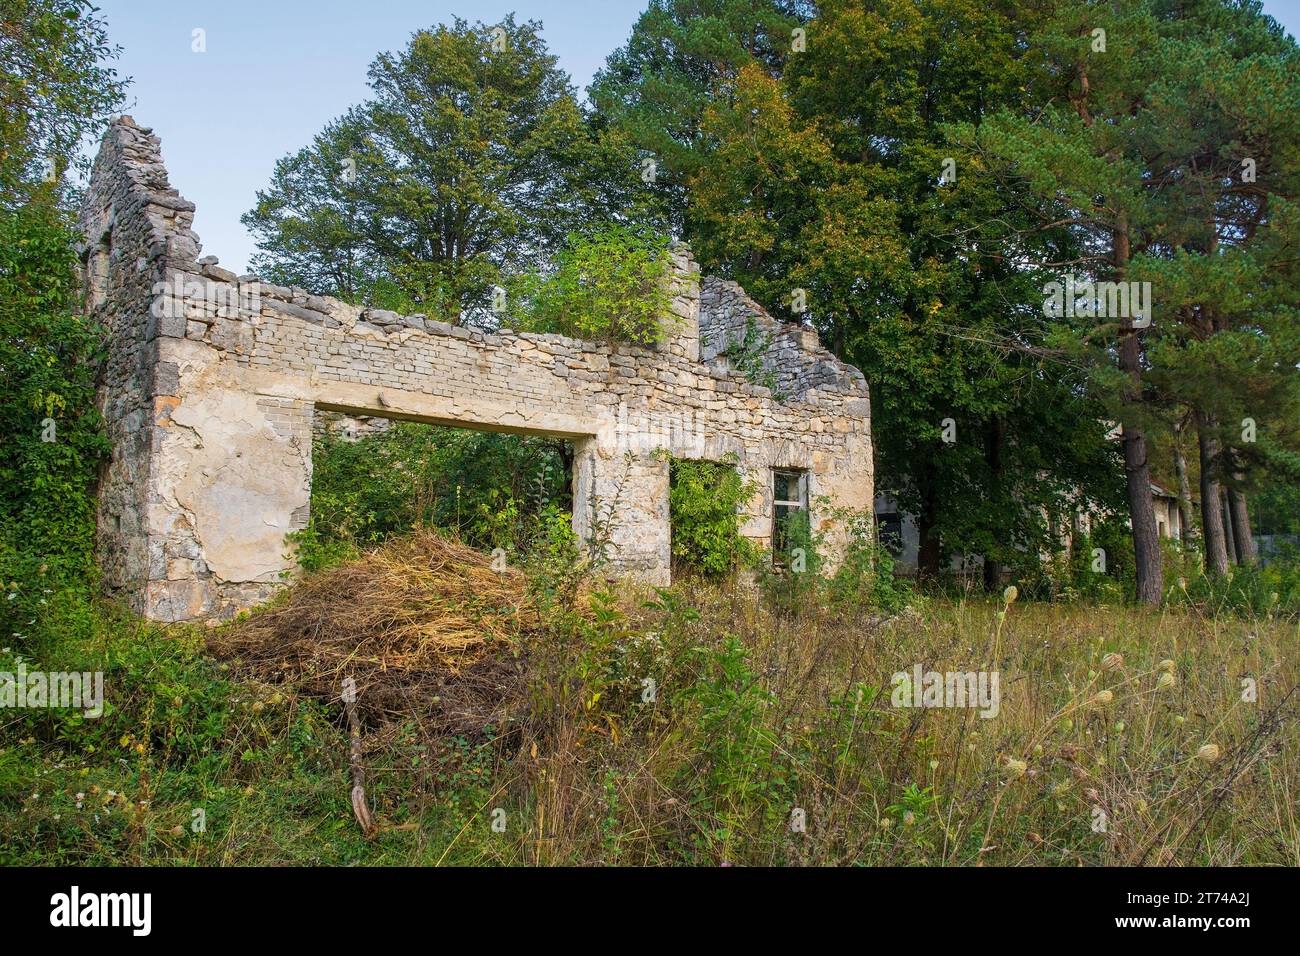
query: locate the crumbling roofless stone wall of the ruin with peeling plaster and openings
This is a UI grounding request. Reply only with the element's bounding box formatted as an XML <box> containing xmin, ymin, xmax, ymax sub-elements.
<box><xmin>82</xmin><ymin>117</ymin><xmax>872</xmax><ymax>620</ymax></box>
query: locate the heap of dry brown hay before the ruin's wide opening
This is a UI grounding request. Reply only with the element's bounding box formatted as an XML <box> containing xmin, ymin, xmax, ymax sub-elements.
<box><xmin>209</xmin><ymin>529</ymin><xmax>540</xmax><ymax>736</ymax></box>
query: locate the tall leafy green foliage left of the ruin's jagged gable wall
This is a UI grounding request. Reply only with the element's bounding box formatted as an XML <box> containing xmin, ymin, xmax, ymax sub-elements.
<box><xmin>0</xmin><ymin>0</ymin><xmax>124</xmax><ymax>653</ymax></box>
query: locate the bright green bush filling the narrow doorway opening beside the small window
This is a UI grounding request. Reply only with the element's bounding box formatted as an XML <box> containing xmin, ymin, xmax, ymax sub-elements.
<box><xmin>668</xmin><ymin>458</ymin><xmax>758</xmax><ymax>578</ymax></box>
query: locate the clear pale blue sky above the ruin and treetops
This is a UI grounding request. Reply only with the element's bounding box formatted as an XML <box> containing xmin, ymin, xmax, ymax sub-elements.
<box><xmin>91</xmin><ymin>0</ymin><xmax>1300</xmax><ymax>272</ymax></box>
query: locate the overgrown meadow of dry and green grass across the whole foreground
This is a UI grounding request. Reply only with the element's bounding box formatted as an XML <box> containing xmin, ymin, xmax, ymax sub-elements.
<box><xmin>0</xmin><ymin>574</ymin><xmax>1300</xmax><ymax>866</ymax></box>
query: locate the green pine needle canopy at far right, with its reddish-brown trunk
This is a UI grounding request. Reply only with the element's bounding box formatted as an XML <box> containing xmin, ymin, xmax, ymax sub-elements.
<box><xmin>977</xmin><ymin>0</ymin><xmax>1300</xmax><ymax>590</ymax></box>
